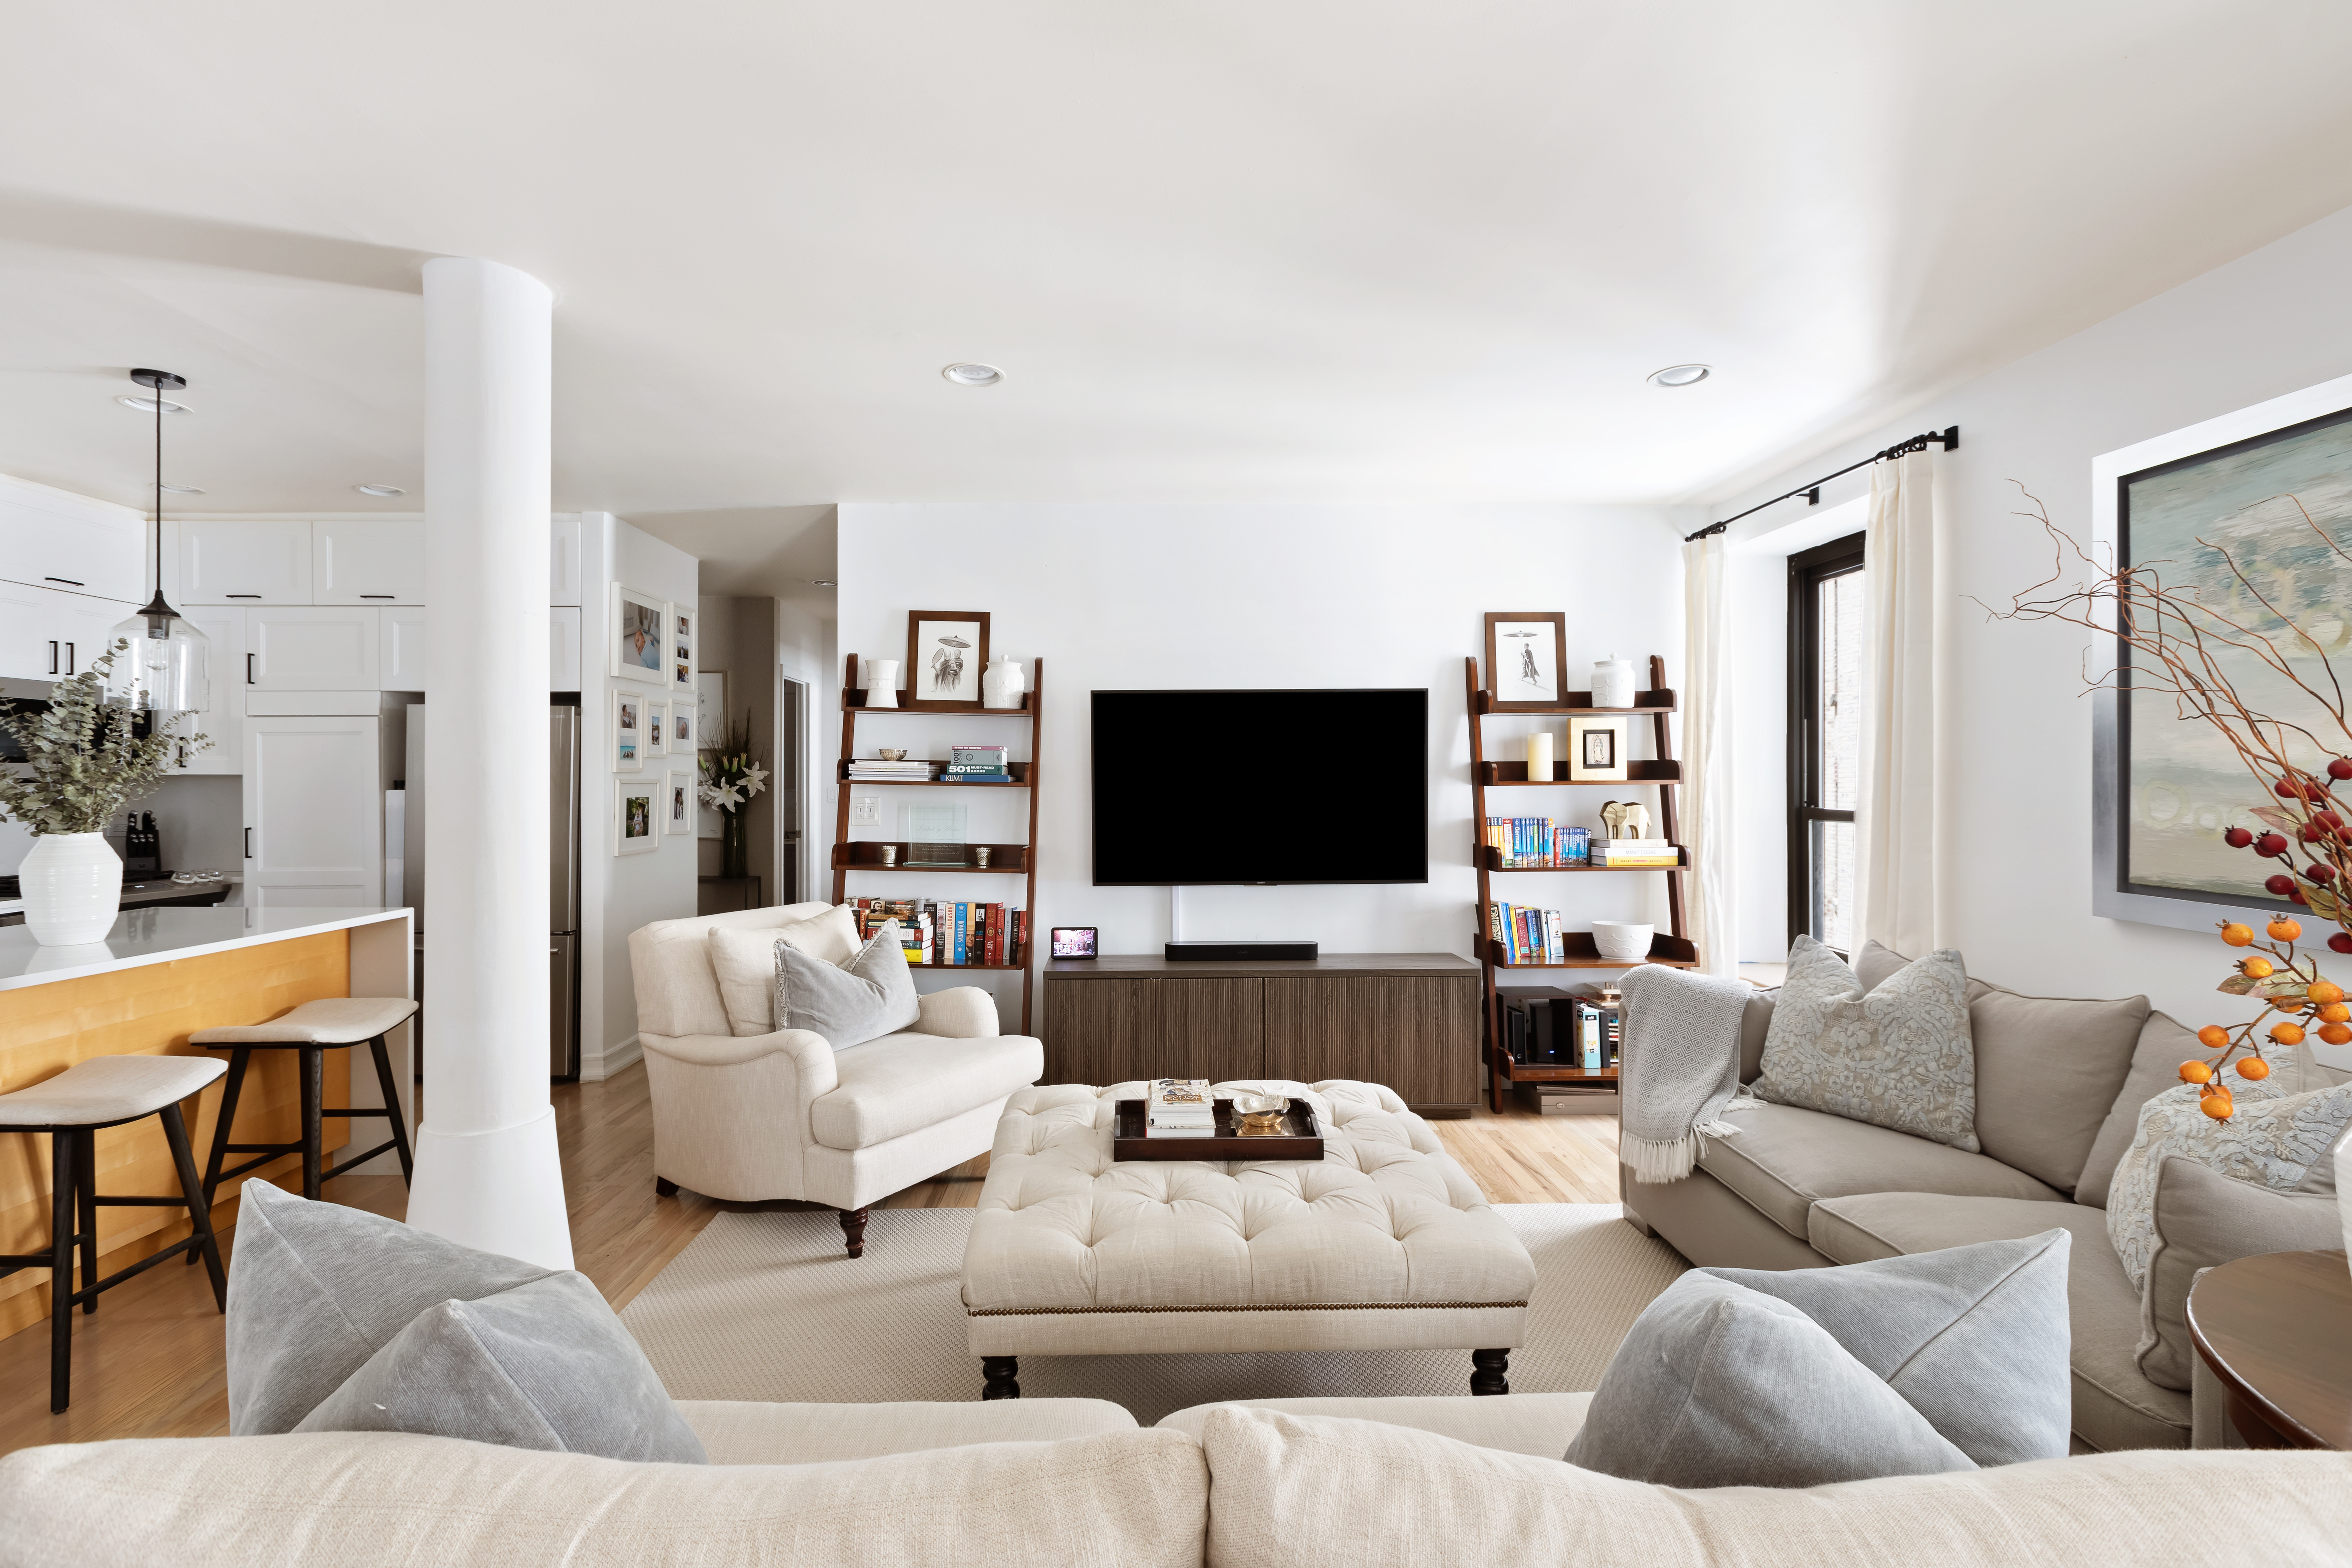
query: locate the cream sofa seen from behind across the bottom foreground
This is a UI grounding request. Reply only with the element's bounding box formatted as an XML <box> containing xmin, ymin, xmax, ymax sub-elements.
<box><xmin>0</xmin><ymin>1394</ymin><xmax>2352</xmax><ymax>1568</ymax></box>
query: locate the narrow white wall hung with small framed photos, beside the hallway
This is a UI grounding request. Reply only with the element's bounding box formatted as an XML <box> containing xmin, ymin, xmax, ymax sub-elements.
<box><xmin>581</xmin><ymin>512</ymin><xmax>699</xmax><ymax>1082</ymax></box>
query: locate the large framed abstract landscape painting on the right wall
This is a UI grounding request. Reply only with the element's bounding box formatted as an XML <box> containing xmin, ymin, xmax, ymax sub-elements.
<box><xmin>2091</xmin><ymin>376</ymin><xmax>2352</xmax><ymax>931</ymax></box>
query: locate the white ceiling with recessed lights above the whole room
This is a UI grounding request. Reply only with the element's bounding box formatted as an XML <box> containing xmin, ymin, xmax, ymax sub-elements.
<box><xmin>0</xmin><ymin>0</ymin><xmax>2352</xmax><ymax>533</ymax></box>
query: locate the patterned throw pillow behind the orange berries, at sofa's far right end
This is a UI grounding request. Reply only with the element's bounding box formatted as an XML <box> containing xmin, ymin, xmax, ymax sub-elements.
<box><xmin>2107</xmin><ymin>1074</ymin><xmax>2352</xmax><ymax>1290</ymax></box>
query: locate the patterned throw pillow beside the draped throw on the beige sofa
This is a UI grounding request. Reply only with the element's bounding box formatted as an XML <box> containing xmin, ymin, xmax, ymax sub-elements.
<box><xmin>1755</xmin><ymin>936</ymin><xmax>1978</xmax><ymax>1154</ymax></box>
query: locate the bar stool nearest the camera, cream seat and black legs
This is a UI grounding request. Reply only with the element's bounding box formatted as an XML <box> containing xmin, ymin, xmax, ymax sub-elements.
<box><xmin>0</xmin><ymin>1056</ymin><xmax>228</xmax><ymax>1413</ymax></box>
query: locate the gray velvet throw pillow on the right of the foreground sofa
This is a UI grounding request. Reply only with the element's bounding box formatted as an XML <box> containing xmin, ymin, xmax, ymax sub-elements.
<box><xmin>1564</xmin><ymin>1230</ymin><xmax>2072</xmax><ymax>1486</ymax></box>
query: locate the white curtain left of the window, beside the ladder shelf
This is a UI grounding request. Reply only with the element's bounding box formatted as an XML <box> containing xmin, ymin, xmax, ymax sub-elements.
<box><xmin>1679</xmin><ymin>534</ymin><xmax>1741</xmax><ymax>978</ymax></box>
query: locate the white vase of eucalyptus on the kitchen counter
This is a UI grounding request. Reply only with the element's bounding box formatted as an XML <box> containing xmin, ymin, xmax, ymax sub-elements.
<box><xmin>0</xmin><ymin>639</ymin><xmax>212</xmax><ymax>947</ymax></box>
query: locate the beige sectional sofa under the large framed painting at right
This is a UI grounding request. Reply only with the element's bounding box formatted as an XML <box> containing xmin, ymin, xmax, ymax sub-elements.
<box><xmin>1618</xmin><ymin>943</ymin><xmax>2347</xmax><ymax>1450</ymax></box>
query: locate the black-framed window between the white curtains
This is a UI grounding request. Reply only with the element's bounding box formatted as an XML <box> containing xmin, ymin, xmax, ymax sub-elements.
<box><xmin>1787</xmin><ymin>534</ymin><xmax>1865</xmax><ymax>954</ymax></box>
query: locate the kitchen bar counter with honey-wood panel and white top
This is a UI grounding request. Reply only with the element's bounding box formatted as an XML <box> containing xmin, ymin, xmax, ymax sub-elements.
<box><xmin>0</xmin><ymin>908</ymin><xmax>416</xmax><ymax>1335</ymax></box>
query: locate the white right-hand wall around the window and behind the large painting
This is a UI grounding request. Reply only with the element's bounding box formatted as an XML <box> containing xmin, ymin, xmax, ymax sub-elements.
<box><xmin>1715</xmin><ymin>200</ymin><xmax>2352</xmax><ymax>1053</ymax></box>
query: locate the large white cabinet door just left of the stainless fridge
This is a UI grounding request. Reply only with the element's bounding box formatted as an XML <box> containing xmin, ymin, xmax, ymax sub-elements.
<box><xmin>245</xmin><ymin>715</ymin><xmax>383</xmax><ymax>910</ymax></box>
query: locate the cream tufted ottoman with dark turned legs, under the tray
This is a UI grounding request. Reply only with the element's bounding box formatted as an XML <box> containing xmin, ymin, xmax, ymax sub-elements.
<box><xmin>964</xmin><ymin>1079</ymin><xmax>1536</xmax><ymax>1399</ymax></box>
